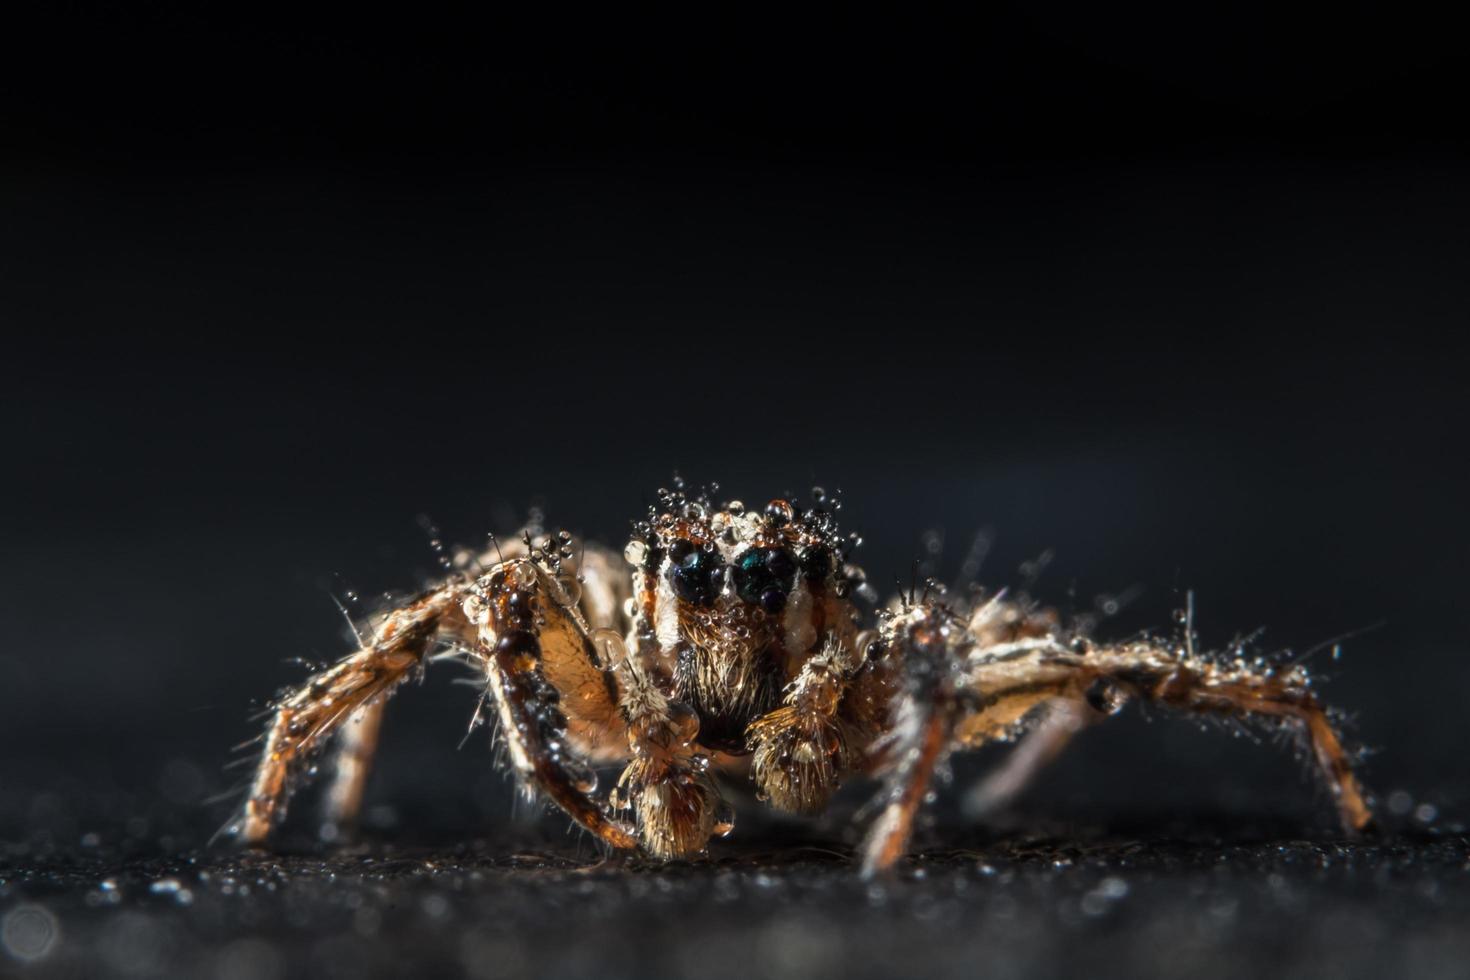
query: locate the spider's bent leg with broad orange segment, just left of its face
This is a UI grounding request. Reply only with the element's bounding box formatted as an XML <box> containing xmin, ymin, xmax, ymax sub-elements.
<box><xmin>465</xmin><ymin>558</ymin><xmax>638</xmax><ymax>848</ymax></box>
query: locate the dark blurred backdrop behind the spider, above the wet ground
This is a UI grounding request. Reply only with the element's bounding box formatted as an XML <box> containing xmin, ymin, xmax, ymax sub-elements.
<box><xmin>0</xmin><ymin>4</ymin><xmax>1470</xmax><ymax>851</ymax></box>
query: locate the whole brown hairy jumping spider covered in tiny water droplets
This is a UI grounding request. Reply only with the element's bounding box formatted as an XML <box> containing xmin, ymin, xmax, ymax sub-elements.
<box><xmin>231</xmin><ymin>483</ymin><xmax>1372</xmax><ymax>874</ymax></box>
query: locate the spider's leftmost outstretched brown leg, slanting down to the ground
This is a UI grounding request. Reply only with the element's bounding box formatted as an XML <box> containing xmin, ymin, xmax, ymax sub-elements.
<box><xmin>240</xmin><ymin>583</ymin><xmax>463</xmax><ymax>843</ymax></box>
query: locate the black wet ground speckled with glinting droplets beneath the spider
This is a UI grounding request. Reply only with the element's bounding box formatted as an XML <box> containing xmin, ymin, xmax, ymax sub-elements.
<box><xmin>0</xmin><ymin>820</ymin><xmax>1470</xmax><ymax>979</ymax></box>
